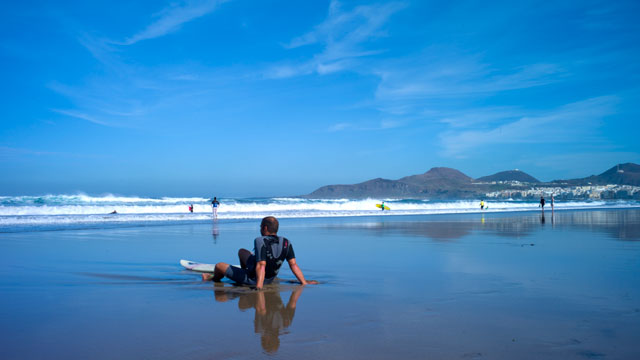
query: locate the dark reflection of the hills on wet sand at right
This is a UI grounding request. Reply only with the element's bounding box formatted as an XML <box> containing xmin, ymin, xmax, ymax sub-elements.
<box><xmin>330</xmin><ymin>209</ymin><xmax>640</xmax><ymax>241</ymax></box>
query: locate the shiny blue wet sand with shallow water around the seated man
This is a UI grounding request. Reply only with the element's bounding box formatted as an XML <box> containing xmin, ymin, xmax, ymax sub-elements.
<box><xmin>0</xmin><ymin>210</ymin><xmax>640</xmax><ymax>359</ymax></box>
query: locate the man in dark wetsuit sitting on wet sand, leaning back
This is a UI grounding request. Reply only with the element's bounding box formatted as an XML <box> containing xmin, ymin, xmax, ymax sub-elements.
<box><xmin>202</xmin><ymin>216</ymin><xmax>318</xmax><ymax>290</ymax></box>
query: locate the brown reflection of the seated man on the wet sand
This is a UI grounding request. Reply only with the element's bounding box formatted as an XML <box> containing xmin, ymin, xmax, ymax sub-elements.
<box><xmin>213</xmin><ymin>283</ymin><xmax>304</xmax><ymax>354</ymax></box>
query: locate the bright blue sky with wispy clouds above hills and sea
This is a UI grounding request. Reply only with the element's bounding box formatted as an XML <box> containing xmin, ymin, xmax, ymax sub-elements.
<box><xmin>0</xmin><ymin>0</ymin><xmax>640</xmax><ymax>197</ymax></box>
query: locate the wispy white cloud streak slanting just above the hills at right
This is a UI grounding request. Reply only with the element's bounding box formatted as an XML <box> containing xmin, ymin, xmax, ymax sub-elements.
<box><xmin>440</xmin><ymin>96</ymin><xmax>618</xmax><ymax>157</ymax></box>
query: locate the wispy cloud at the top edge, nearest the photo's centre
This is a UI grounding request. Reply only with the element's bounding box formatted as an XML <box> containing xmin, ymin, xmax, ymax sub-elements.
<box><xmin>265</xmin><ymin>1</ymin><xmax>405</xmax><ymax>78</ymax></box>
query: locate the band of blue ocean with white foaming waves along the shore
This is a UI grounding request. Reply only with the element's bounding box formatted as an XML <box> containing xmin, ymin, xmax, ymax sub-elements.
<box><xmin>0</xmin><ymin>194</ymin><xmax>640</xmax><ymax>232</ymax></box>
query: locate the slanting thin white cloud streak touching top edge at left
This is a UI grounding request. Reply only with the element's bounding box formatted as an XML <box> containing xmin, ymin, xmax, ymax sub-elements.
<box><xmin>113</xmin><ymin>0</ymin><xmax>226</xmax><ymax>45</ymax></box>
